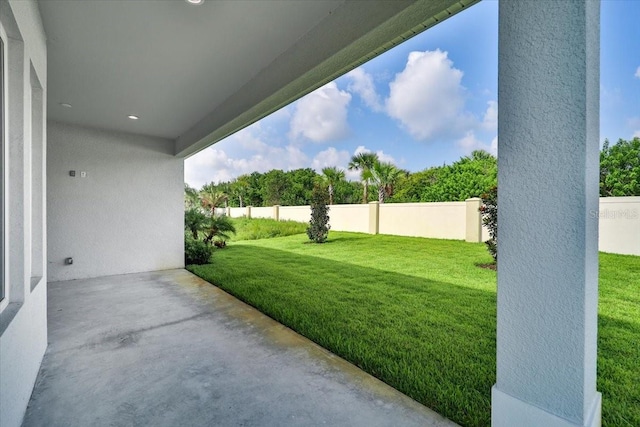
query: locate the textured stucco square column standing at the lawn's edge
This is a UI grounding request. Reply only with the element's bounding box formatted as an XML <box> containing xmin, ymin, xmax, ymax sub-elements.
<box><xmin>492</xmin><ymin>0</ymin><xmax>601</xmax><ymax>427</ymax></box>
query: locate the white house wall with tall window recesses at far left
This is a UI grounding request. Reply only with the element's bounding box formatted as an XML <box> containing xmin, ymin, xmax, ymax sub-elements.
<box><xmin>0</xmin><ymin>1</ymin><xmax>47</xmax><ymax>427</ymax></box>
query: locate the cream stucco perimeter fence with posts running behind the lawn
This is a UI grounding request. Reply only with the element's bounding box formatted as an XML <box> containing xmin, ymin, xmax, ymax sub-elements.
<box><xmin>219</xmin><ymin>197</ymin><xmax>640</xmax><ymax>255</ymax></box>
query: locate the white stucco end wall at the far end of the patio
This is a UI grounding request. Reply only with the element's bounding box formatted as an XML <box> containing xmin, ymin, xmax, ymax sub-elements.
<box><xmin>47</xmin><ymin>122</ymin><xmax>184</xmax><ymax>281</ymax></box>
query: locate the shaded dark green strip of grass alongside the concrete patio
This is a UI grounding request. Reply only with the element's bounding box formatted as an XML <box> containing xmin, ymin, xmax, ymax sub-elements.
<box><xmin>190</xmin><ymin>244</ymin><xmax>496</xmax><ymax>426</ymax></box>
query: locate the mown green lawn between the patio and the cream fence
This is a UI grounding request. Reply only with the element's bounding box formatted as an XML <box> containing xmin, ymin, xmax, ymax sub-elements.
<box><xmin>189</xmin><ymin>232</ymin><xmax>640</xmax><ymax>426</ymax></box>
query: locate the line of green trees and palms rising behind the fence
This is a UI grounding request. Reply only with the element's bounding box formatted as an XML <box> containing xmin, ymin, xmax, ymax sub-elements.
<box><xmin>185</xmin><ymin>138</ymin><xmax>640</xmax><ymax>207</ymax></box>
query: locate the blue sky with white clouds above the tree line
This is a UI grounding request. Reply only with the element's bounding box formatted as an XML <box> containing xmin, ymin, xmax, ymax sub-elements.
<box><xmin>185</xmin><ymin>0</ymin><xmax>640</xmax><ymax>188</ymax></box>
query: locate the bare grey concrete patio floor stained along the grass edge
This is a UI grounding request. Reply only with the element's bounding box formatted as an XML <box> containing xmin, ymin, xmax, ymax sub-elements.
<box><xmin>23</xmin><ymin>270</ymin><xmax>456</xmax><ymax>427</ymax></box>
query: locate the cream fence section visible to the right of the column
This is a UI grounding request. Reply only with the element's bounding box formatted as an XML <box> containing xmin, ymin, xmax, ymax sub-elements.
<box><xmin>589</xmin><ymin>197</ymin><xmax>640</xmax><ymax>255</ymax></box>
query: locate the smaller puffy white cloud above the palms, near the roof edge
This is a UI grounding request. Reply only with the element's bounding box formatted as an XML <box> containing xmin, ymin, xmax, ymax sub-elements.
<box><xmin>290</xmin><ymin>82</ymin><xmax>351</xmax><ymax>142</ymax></box>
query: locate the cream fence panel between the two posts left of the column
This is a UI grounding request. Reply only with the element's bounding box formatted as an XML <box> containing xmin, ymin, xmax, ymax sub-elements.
<box><xmin>379</xmin><ymin>202</ymin><xmax>466</xmax><ymax>240</ymax></box>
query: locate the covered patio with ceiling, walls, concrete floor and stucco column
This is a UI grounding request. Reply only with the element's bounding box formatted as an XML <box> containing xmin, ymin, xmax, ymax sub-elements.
<box><xmin>0</xmin><ymin>0</ymin><xmax>601</xmax><ymax>427</ymax></box>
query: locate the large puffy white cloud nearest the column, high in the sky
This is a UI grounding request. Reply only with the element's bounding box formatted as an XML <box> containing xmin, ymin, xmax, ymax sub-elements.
<box><xmin>386</xmin><ymin>49</ymin><xmax>474</xmax><ymax>140</ymax></box>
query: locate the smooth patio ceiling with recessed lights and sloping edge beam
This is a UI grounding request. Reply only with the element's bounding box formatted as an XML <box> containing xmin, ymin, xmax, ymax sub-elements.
<box><xmin>39</xmin><ymin>0</ymin><xmax>478</xmax><ymax>156</ymax></box>
